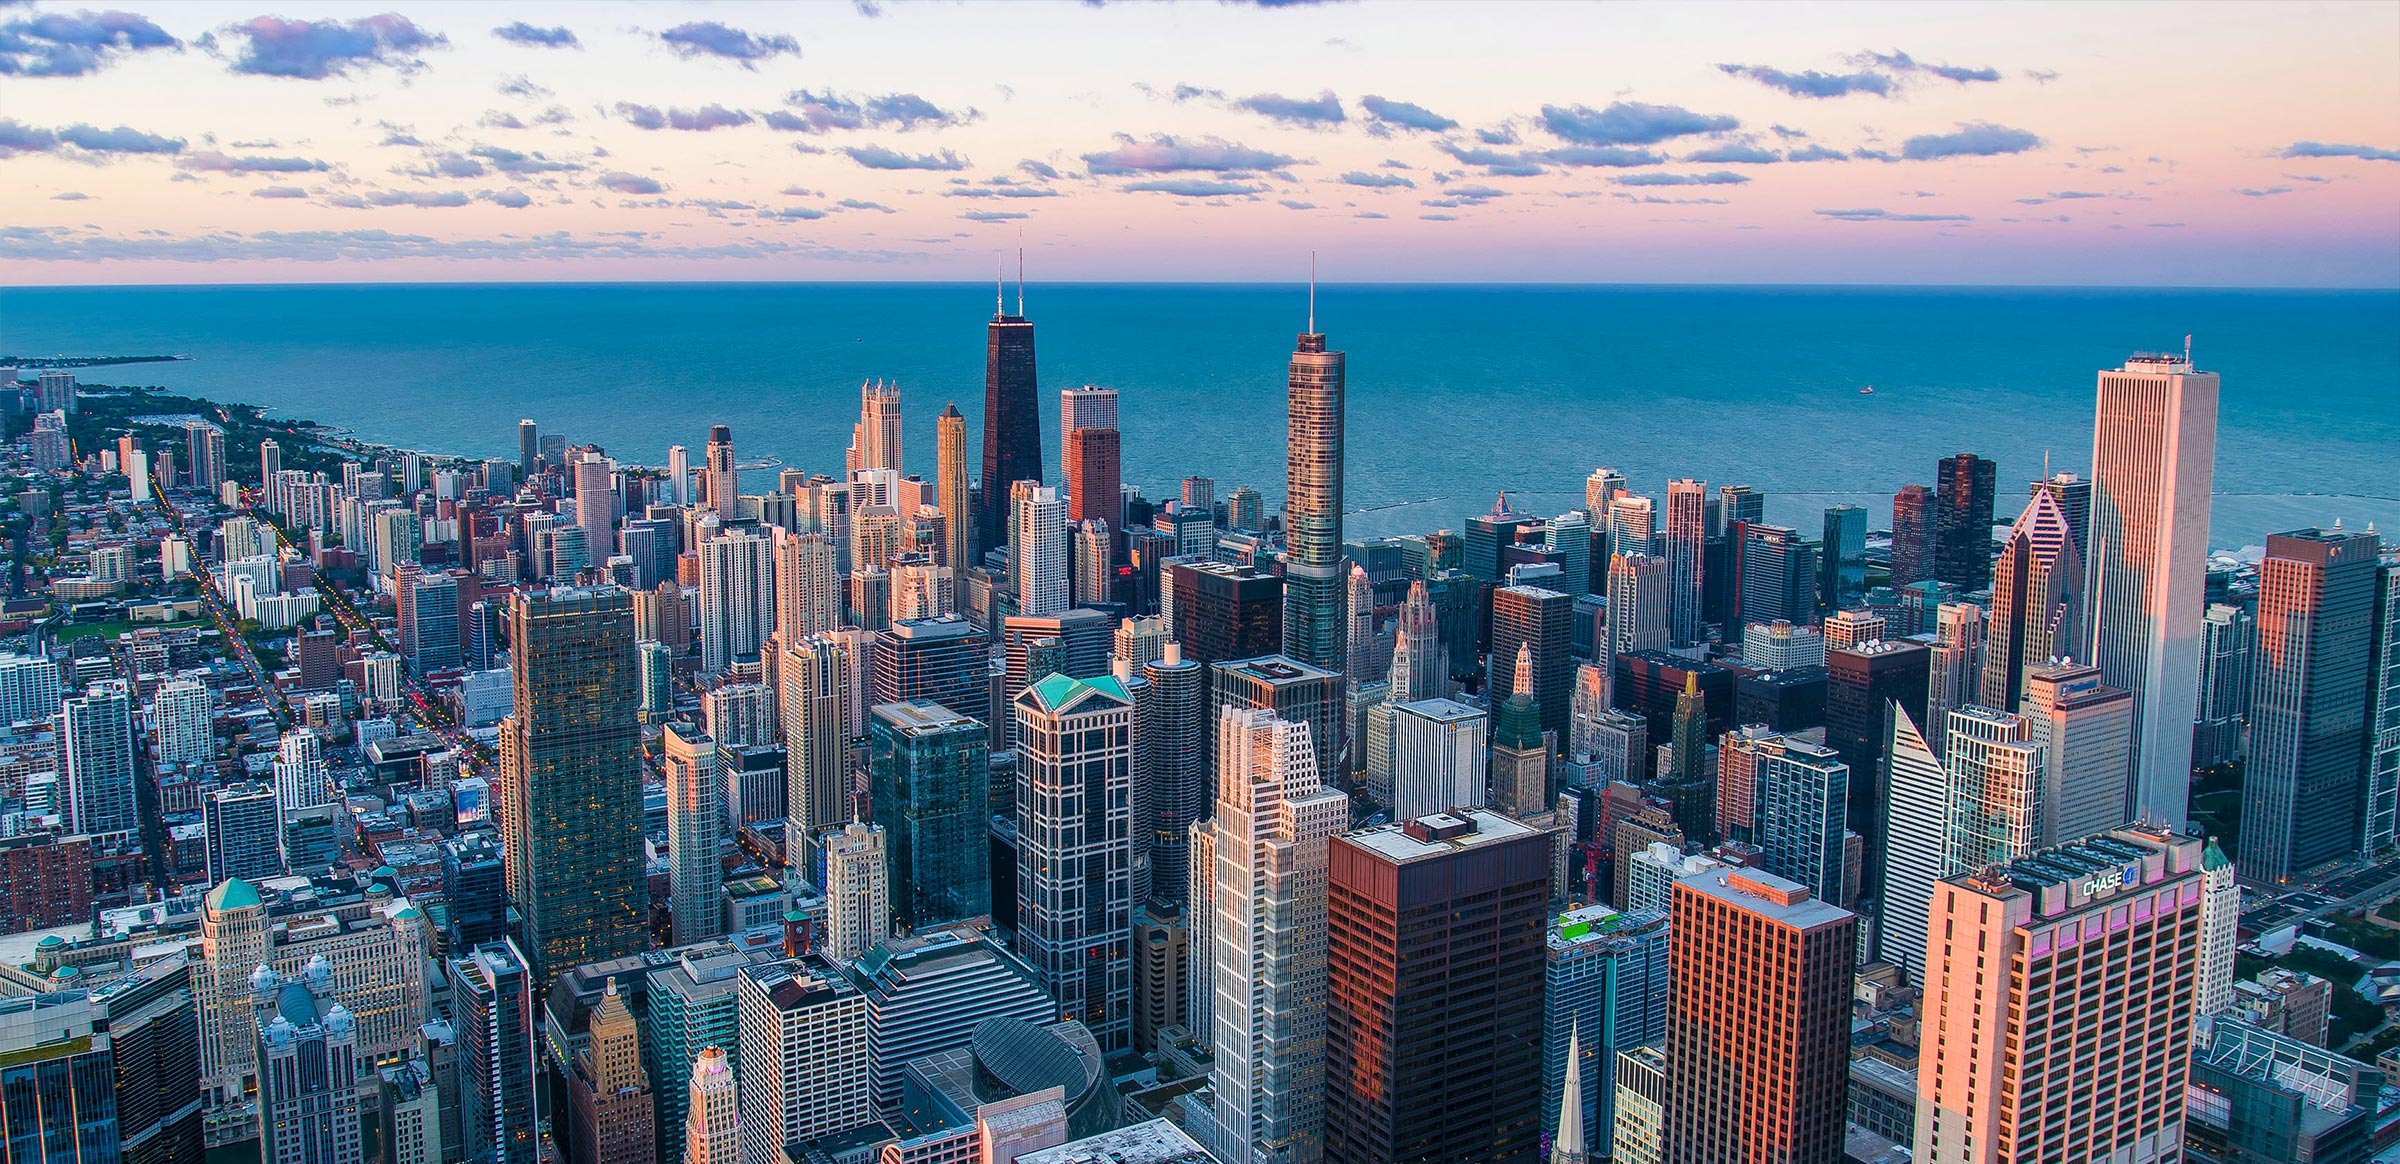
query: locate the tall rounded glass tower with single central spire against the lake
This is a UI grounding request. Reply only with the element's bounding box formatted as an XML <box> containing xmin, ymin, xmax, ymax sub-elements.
<box><xmin>1284</xmin><ymin>309</ymin><xmax>1349</xmax><ymax>672</ymax></box>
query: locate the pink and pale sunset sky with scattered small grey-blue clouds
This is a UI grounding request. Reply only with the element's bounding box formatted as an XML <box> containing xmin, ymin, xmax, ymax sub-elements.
<box><xmin>0</xmin><ymin>0</ymin><xmax>2400</xmax><ymax>288</ymax></box>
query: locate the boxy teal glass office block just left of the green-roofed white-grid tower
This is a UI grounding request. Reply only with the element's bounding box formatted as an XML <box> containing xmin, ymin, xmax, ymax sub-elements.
<box><xmin>866</xmin><ymin>703</ymin><xmax>991</xmax><ymax>931</ymax></box>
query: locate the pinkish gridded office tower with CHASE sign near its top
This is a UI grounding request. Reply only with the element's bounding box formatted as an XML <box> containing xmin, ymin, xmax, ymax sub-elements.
<box><xmin>1913</xmin><ymin>828</ymin><xmax>2201</xmax><ymax>1164</ymax></box>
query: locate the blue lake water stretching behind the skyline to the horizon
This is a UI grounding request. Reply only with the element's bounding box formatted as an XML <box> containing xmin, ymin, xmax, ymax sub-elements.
<box><xmin>0</xmin><ymin>283</ymin><xmax>2400</xmax><ymax>547</ymax></box>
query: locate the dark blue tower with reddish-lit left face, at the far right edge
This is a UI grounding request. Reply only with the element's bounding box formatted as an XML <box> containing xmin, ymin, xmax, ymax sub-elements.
<box><xmin>2237</xmin><ymin>528</ymin><xmax>2381</xmax><ymax>886</ymax></box>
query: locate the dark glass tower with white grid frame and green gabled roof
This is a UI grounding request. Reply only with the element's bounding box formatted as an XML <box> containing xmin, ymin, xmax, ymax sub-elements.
<box><xmin>1013</xmin><ymin>674</ymin><xmax>1133</xmax><ymax>1054</ymax></box>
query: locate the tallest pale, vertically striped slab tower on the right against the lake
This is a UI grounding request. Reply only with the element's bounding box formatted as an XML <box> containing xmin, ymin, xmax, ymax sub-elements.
<box><xmin>2081</xmin><ymin>353</ymin><xmax>2218</xmax><ymax>826</ymax></box>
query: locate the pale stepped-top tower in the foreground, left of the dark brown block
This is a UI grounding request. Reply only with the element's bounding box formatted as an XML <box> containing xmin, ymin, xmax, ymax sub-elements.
<box><xmin>1193</xmin><ymin>708</ymin><xmax>1349</xmax><ymax>1164</ymax></box>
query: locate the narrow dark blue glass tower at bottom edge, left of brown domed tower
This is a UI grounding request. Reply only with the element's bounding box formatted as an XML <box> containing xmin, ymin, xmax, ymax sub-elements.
<box><xmin>444</xmin><ymin>940</ymin><xmax>537</xmax><ymax>1164</ymax></box>
